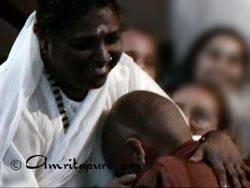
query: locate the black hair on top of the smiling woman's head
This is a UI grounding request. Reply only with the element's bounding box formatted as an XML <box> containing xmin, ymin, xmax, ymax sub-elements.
<box><xmin>35</xmin><ymin>0</ymin><xmax>121</xmax><ymax>36</ymax></box>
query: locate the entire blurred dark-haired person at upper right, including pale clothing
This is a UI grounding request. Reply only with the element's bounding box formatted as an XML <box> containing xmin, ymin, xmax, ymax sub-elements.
<box><xmin>181</xmin><ymin>27</ymin><xmax>250</xmax><ymax>158</ymax></box>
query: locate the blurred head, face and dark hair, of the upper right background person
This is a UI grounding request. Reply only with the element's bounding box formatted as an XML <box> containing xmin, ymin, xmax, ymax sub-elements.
<box><xmin>183</xmin><ymin>27</ymin><xmax>248</xmax><ymax>92</ymax></box>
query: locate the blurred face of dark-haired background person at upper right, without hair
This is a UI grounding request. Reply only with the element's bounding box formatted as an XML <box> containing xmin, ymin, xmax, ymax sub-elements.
<box><xmin>195</xmin><ymin>35</ymin><xmax>244</xmax><ymax>91</ymax></box>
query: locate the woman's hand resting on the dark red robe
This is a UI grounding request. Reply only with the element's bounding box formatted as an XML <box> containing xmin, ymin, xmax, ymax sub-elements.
<box><xmin>190</xmin><ymin>132</ymin><xmax>246</xmax><ymax>187</ymax></box>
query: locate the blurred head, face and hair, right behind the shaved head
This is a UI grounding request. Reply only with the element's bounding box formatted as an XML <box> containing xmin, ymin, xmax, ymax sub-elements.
<box><xmin>172</xmin><ymin>83</ymin><xmax>230</xmax><ymax>138</ymax></box>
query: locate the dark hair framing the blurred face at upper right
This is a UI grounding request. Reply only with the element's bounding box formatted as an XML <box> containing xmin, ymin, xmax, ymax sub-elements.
<box><xmin>181</xmin><ymin>27</ymin><xmax>249</xmax><ymax>83</ymax></box>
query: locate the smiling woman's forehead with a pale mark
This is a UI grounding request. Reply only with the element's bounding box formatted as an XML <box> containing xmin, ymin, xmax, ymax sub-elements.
<box><xmin>68</xmin><ymin>8</ymin><xmax>120</xmax><ymax>38</ymax></box>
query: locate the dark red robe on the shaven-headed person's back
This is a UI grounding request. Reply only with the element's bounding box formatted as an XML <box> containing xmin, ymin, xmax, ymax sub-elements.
<box><xmin>135</xmin><ymin>141</ymin><xmax>219</xmax><ymax>188</ymax></box>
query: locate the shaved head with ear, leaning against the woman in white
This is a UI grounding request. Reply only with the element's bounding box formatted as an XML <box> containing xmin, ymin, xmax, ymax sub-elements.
<box><xmin>102</xmin><ymin>91</ymin><xmax>192</xmax><ymax>176</ymax></box>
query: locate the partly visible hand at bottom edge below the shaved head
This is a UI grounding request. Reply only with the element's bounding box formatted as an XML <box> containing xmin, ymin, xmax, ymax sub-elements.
<box><xmin>108</xmin><ymin>174</ymin><xmax>136</xmax><ymax>188</ymax></box>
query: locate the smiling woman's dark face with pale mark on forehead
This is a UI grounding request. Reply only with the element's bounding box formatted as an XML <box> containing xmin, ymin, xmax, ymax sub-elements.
<box><xmin>42</xmin><ymin>8</ymin><xmax>122</xmax><ymax>89</ymax></box>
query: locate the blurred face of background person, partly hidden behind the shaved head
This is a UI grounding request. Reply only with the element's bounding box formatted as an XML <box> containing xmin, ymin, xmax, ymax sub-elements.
<box><xmin>173</xmin><ymin>86</ymin><xmax>219</xmax><ymax>135</ymax></box>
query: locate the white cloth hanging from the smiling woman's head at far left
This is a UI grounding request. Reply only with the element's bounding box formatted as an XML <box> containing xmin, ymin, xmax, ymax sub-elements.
<box><xmin>0</xmin><ymin>12</ymin><xmax>43</xmax><ymax>160</ymax></box>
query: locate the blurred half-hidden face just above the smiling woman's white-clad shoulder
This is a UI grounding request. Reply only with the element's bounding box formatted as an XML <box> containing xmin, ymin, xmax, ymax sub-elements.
<box><xmin>122</xmin><ymin>31</ymin><xmax>157</xmax><ymax>79</ymax></box>
